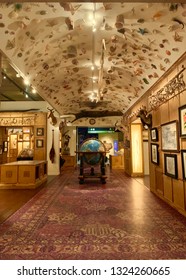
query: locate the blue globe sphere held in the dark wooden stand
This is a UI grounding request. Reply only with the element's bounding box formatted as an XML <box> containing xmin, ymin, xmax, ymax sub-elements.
<box><xmin>80</xmin><ymin>138</ymin><xmax>106</xmax><ymax>165</ymax></box>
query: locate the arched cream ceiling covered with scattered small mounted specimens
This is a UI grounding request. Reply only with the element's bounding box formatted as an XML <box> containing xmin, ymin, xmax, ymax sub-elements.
<box><xmin>0</xmin><ymin>2</ymin><xmax>186</xmax><ymax>117</ymax></box>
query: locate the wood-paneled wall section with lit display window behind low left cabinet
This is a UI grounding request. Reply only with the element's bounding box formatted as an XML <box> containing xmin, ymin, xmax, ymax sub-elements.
<box><xmin>0</xmin><ymin>112</ymin><xmax>47</xmax><ymax>163</ymax></box>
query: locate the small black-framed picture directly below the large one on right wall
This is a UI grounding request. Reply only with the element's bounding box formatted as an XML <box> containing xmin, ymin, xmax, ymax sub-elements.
<box><xmin>164</xmin><ymin>154</ymin><xmax>178</xmax><ymax>179</ymax></box>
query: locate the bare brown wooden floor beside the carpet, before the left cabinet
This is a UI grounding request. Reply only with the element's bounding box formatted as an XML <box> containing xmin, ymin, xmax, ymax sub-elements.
<box><xmin>0</xmin><ymin>176</ymin><xmax>55</xmax><ymax>223</ymax></box>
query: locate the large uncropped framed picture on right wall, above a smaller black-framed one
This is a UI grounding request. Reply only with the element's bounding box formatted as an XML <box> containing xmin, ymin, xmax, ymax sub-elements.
<box><xmin>161</xmin><ymin>121</ymin><xmax>179</xmax><ymax>152</ymax></box>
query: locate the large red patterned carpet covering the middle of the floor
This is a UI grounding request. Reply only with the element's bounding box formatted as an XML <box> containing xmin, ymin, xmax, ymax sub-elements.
<box><xmin>0</xmin><ymin>167</ymin><xmax>186</xmax><ymax>260</ymax></box>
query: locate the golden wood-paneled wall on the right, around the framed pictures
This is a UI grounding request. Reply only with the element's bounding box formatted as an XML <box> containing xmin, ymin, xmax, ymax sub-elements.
<box><xmin>124</xmin><ymin>54</ymin><xmax>186</xmax><ymax>216</ymax></box>
